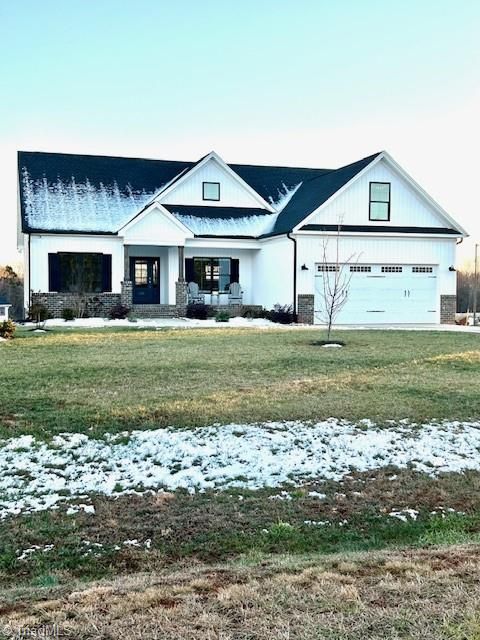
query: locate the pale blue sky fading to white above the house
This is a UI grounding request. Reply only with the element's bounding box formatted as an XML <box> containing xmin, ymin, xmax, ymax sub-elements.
<box><xmin>0</xmin><ymin>0</ymin><xmax>480</xmax><ymax>264</ymax></box>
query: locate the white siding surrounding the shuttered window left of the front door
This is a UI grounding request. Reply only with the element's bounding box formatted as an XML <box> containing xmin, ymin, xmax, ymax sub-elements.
<box><xmin>30</xmin><ymin>235</ymin><xmax>124</xmax><ymax>293</ymax></box>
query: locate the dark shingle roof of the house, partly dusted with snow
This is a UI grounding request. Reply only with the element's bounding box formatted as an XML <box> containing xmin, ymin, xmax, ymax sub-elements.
<box><xmin>18</xmin><ymin>151</ymin><xmax>378</xmax><ymax>236</ymax></box>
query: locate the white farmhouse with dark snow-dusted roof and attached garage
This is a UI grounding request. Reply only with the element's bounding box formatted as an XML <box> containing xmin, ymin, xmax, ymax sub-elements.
<box><xmin>18</xmin><ymin>152</ymin><xmax>466</xmax><ymax>324</ymax></box>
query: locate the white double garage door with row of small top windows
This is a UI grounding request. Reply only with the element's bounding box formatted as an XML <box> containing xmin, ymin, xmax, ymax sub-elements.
<box><xmin>315</xmin><ymin>264</ymin><xmax>438</xmax><ymax>324</ymax></box>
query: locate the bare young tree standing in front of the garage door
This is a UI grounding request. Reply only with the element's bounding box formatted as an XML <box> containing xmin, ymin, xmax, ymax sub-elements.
<box><xmin>315</xmin><ymin>223</ymin><xmax>358</xmax><ymax>340</ymax></box>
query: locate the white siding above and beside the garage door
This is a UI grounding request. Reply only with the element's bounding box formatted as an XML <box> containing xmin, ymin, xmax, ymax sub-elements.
<box><xmin>297</xmin><ymin>235</ymin><xmax>457</xmax><ymax>295</ymax></box>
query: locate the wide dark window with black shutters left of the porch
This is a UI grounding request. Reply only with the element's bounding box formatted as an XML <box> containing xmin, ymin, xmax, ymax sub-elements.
<box><xmin>48</xmin><ymin>252</ymin><xmax>112</xmax><ymax>293</ymax></box>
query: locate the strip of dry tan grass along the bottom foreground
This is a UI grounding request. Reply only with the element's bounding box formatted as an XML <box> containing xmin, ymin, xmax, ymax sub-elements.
<box><xmin>0</xmin><ymin>546</ymin><xmax>480</xmax><ymax>640</ymax></box>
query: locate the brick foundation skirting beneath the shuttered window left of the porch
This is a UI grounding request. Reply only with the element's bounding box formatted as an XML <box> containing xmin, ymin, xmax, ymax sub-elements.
<box><xmin>32</xmin><ymin>292</ymin><xmax>121</xmax><ymax>318</ymax></box>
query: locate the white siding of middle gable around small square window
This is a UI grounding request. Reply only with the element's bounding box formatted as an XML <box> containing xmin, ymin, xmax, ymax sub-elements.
<box><xmin>160</xmin><ymin>158</ymin><xmax>263</xmax><ymax>208</ymax></box>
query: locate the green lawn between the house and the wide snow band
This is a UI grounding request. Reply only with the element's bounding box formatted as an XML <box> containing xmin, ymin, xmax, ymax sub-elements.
<box><xmin>0</xmin><ymin>328</ymin><xmax>480</xmax><ymax>437</ymax></box>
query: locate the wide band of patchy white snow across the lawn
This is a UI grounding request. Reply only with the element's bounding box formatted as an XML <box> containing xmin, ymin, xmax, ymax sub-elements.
<box><xmin>0</xmin><ymin>418</ymin><xmax>480</xmax><ymax>517</ymax></box>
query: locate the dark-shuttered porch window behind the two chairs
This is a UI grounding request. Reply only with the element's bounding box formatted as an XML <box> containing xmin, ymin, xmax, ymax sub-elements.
<box><xmin>185</xmin><ymin>258</ymin><xmax>239</xmax><ymax>293</ymax></box>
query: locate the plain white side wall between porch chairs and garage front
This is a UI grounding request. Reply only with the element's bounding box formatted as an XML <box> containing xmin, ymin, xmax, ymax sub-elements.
<box><xmin>253</xmin><ymin>237</ymin><xmax>293</xmax><ymax>309</ymax></box>
